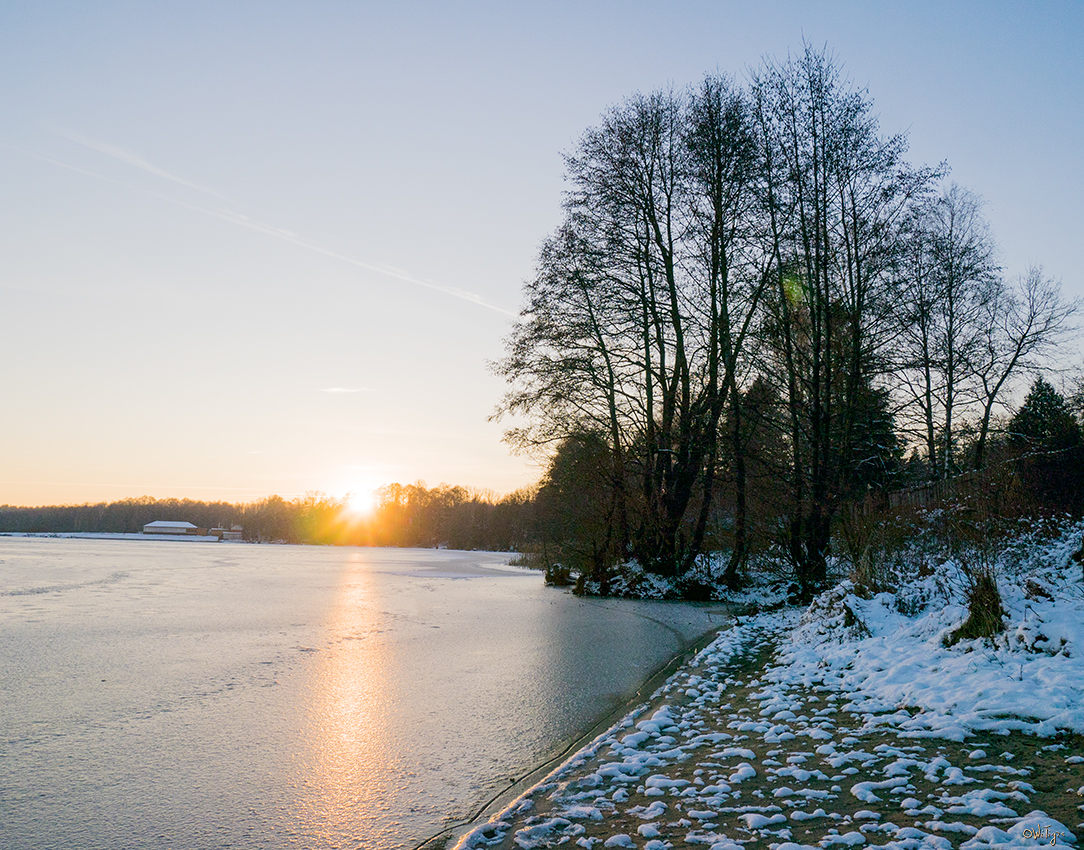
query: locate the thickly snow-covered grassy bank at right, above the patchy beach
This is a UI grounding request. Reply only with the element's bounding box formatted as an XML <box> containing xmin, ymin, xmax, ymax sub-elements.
<box><xmin>776</xmin><ymin>513</ymin><xmax>1084</xmax><ymax>739</ymax></box>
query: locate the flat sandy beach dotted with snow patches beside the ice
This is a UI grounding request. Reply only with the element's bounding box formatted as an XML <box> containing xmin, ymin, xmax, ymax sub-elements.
<box><xmin>455</xmin><ymin>611</ymin><xmax>1084</xmax><ymax>850</ymax></box>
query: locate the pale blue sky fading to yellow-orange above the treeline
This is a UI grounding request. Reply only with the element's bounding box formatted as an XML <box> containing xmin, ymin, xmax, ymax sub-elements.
<box><xmin>0</xmin><ymin>0</ymin><xmax>1084</xmax><ymax>504</ymax></box>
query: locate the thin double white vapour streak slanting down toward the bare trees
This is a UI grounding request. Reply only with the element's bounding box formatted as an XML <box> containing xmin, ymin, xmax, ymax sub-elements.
<box><xmin>22</xmin><ymin>137</ymin><xmax>516</xmax><ymax>318</ymax></box>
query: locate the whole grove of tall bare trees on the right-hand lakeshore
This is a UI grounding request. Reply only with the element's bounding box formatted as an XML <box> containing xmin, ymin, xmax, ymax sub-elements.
<box><xmin>495</xmin><ymin>47</ymin><xmax>1077</xmax><ymax>596</ymax></box>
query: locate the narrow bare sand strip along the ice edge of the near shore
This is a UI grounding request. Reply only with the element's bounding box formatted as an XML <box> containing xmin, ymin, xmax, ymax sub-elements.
<box><xmin>412</xmin><ymin>603</ymin><xmax>739</xmax><ymax>850</ymax></box>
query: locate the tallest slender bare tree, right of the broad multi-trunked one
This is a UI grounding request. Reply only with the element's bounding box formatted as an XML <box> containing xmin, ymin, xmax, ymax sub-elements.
<box><xmin>754</xmin><ymin>46</ymin><xmax>932</xmax><ymax>593</ymax></box>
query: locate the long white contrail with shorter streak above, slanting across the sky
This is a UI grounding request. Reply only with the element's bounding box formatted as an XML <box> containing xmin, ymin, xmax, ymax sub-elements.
<box><xmin>19</xmin><ymin>130</ymin><xmax>516</xmax><ymax>318</ymax></box>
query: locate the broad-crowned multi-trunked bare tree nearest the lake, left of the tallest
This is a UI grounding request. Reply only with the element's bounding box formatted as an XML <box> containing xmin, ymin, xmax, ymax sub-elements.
<box><xmin>498</xmin><ymin>78</ymin><xmax>767</xmax><ymax>574</ymax></box>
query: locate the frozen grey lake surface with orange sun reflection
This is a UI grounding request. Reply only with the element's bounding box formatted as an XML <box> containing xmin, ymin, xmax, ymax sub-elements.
<box><xmin>0</xmin><ymin>538</ymin><xmax>724</xmax><ymax>850</ymax></box>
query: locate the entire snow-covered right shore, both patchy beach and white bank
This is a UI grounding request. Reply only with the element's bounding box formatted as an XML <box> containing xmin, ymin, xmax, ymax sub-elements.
<box><xmin>457</xmin><ymin>513</ymin><xmax>1084</xmax><ymax>850</ymax></box>
